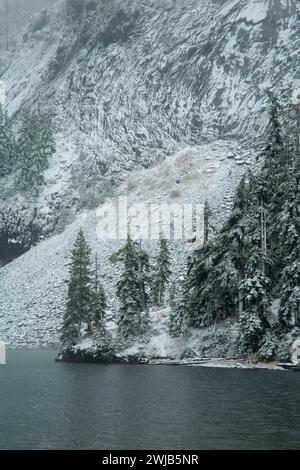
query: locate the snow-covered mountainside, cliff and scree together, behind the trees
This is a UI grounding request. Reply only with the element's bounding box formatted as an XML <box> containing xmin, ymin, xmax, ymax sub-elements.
<box><xmin>0</xmin><ymin>0</ymin><xmax>300</xmax><ymax>345</ymax></box>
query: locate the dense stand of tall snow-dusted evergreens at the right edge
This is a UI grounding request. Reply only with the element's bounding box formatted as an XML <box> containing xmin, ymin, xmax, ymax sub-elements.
<box><xmin>189</xmin><ymin>88</ymin><xmax>300</xmax><ymax>352</ymax></box>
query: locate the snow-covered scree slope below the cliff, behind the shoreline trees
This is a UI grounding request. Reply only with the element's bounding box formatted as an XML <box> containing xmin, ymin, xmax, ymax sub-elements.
<box><xmin>0</xmin><ymin>141</ymin><xmax>250</xmax><ymax>348</ymax></box>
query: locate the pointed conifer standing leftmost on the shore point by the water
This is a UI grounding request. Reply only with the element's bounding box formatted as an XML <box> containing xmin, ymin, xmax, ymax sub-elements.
<box><xmin>61</xmin><ymin>230</ymin><xmax>92</xmax><ymax>343</ymax></box>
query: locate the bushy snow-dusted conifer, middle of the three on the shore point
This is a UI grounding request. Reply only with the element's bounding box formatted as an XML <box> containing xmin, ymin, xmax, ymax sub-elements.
<box><xmin>111</xmin><ymin>237</ymin><xmax>149</xmax><ymax>338</ymax></box>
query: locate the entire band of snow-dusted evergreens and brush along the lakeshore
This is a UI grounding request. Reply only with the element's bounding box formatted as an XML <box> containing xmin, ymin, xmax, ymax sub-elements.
<box><xmin>59</xmin><ymin>91</ymin><xmax>300</xmax><ymax>368</ymax></box>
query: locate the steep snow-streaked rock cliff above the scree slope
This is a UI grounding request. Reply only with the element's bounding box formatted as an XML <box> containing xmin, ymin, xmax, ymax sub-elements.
<box><xmin>2</xmin><ymin>0</ymin><xmax>300</xmax><ymax>179</ymax></box>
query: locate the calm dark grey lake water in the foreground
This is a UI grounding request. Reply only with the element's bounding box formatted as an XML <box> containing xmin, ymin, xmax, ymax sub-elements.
<box><xmin>0</xmin><ymin>351</ymin><xmax>300</xmax><ymax>450</ymax></box>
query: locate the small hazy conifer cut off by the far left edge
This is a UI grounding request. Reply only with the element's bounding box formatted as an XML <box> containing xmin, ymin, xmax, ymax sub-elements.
<box><xmin>0</xmin><ymin>104</ymin><xmax>16</xmax><ymax>177</ymax></box>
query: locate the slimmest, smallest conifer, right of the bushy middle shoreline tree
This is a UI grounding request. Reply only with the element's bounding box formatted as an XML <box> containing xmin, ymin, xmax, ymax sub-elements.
<box><xmin>151</xmin><ymin>238</ymin><xmax>171</xmax><ymax>306</ymax></box>
